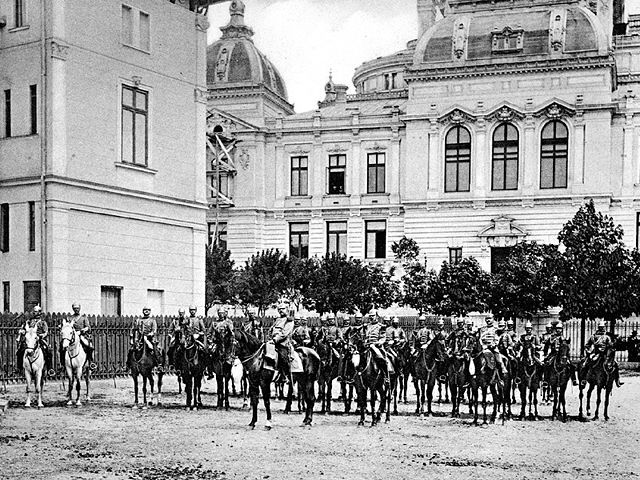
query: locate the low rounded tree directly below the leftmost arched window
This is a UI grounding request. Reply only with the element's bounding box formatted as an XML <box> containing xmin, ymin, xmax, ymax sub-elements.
<box><xmin>427</xmin><ymin>257</ymin><xmax>490</xmax><ymax>316</ymax></box>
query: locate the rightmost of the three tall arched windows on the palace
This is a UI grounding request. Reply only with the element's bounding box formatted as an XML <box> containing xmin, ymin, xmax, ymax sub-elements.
<box><xmin>540</xmin><ymin>120</ymin><xmax>569</xmax><ymax>188</ymax></box>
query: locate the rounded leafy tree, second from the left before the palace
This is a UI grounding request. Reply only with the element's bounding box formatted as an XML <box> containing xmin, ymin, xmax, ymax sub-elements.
<box><xmin>234</xmin><ymin>249</ymin><xmax>290</xmax><ymax>315</ymax></box>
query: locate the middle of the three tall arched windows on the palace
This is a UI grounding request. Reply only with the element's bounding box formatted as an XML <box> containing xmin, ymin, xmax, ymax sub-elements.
<box><xmin>491</xmin><ymin>123</ymin><xmax>518</xmax><ymax>190</ymax></box>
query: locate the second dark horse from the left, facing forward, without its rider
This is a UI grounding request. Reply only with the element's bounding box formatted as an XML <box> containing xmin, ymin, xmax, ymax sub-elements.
<box><xmin>175</xmin><ymin>329</ymin><xmax>207</xmax><ymax>410</ymax></box>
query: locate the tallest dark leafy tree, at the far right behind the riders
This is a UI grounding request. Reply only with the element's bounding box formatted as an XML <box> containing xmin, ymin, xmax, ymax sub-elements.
<box><xmin>558</xmin><ymin>200</ymin><xmax>638</xmax><ymax>346</ymax></box>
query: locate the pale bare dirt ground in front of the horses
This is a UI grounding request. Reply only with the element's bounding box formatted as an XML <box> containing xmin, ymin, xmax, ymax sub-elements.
<box><xmin>0</xmin><ymin>375</ymin><xmax>640</xmax><ymax>480</ymax></box>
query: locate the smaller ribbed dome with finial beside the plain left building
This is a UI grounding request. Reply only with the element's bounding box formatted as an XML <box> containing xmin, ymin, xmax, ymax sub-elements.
<box><xmin>207</xmin><ymin>0</ymin><xmax>287</xmax><ymax>100</ymax></box>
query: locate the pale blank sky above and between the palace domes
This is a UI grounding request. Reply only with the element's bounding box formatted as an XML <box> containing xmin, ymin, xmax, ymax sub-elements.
<box><xmin>209</xmin><ymin>0</ymin><xmax>640</xmax><ymax>112</ymax></box>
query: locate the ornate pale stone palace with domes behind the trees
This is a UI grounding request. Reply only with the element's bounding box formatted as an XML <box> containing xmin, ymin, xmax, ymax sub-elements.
<box><xmin>207</xmin><ymin>0</ymin><xmax>640</xmax><ymax>270</ymax></box>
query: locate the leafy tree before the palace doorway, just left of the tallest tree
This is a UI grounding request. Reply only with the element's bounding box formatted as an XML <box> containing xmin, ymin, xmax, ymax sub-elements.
<box><xmin>489</xmin><ymin>242</ymin><xmax>560</xmax><ymax>319</ymax></box>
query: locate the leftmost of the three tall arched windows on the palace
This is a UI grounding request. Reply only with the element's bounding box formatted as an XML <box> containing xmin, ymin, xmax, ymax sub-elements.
<box><xmin>444</xmin><ymin>127</ymin><xmax>471</xmax><ymax>192</ymax></box>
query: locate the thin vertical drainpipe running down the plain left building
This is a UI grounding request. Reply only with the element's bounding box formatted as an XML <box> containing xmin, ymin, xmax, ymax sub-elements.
<box><xmin>40</xmin><ymin>0</ymin><xmax>49</xmax><ymax>312</ymax></box>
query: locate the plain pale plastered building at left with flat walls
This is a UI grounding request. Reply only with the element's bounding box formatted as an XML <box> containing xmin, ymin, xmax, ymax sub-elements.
<box><xmin>0</xmin><ymin>0</ymin><xmax>208</xmax><ymax>315</ymax></box>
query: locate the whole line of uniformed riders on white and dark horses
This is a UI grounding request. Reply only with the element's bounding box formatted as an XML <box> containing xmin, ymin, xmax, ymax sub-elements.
<box><xmin>13</xmin><ymin>304</ymin><xmax>621</xmax><ymax>428</ymax></box>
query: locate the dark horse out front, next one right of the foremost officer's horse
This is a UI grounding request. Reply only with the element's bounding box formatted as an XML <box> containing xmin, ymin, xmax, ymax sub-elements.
<box><xmin>353</xmin><ymin>344</ymin><xmax>396</xmax><ymax>427</ymax></box>
